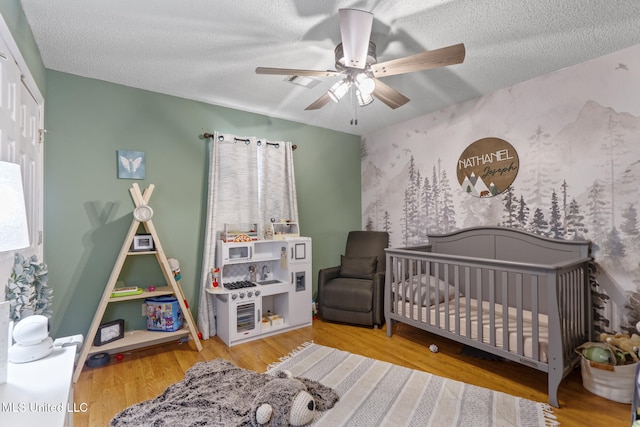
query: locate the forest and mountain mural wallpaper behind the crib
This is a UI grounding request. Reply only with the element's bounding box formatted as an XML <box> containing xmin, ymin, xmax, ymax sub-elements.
<box><xmin>361</xmin><ymin>42</ymin><xmax>640</xmax><ymax>331</ymax></box>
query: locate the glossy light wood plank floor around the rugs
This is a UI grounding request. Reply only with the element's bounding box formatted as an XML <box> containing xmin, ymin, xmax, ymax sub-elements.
<box><xmin>73</xmin><ymin>320</ymin><xmax>631</xmax><ymax>427</ymax></box>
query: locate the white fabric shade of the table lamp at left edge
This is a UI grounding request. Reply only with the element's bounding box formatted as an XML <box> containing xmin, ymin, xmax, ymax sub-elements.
<box><xmin>0</xmin><ymin>162</ymin><xmax>29</xmax><ymax>252</ymax></box>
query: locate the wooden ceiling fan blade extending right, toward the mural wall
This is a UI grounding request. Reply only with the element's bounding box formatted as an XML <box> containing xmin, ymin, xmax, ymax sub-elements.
<box><xmin>371</xmin><ymin>43</ymin><xmax>465</xmax><ymax>77</ymax></box>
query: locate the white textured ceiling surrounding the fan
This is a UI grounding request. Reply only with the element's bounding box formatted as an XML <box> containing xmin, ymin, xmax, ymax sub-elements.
<box><xmin>22</xmin><ymin>0</ymin><xmax>640</xmax><ymax>135</ymax></box>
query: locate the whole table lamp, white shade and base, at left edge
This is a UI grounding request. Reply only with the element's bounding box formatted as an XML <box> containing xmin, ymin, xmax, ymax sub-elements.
<box><xmin>0</xmin><ymin>162</ymin><xmax>29</xmax><ymax>384</ymax></box>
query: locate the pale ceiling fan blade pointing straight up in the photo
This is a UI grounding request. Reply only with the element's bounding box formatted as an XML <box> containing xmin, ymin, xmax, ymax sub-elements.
<box><xmin>338</xmin><ymin>9</ymin><xmax>373</xmax><ymax>69</ymax></box>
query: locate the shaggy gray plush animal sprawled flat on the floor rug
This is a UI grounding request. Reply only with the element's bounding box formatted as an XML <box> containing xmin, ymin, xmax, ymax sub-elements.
<box><xmin>110</xmin><ymin>359</ymin><xmax>338</xmax><ymax>427</ymax></box>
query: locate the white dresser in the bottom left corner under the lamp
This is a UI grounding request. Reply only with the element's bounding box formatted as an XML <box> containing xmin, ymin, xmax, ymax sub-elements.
<box><xmin>0</xmin><ymin>346</ymin><xmax>76</xmax><ymax>427</ymax></box>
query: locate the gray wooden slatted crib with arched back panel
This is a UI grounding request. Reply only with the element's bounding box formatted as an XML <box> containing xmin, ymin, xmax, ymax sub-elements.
<box><xmin>385</xmin><ymin>227</ymin><xmax>593</xmax><ymax>407</ymax></box>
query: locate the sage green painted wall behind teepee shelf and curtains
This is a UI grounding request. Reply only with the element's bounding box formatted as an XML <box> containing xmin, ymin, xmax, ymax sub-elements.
<box><xmin>44</xmin><ymin>70</ymin><xmax>361</xmax><ymax>342</ymax></box>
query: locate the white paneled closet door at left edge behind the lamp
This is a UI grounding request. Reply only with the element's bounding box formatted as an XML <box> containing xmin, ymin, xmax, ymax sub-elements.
<box><xmin>0</xmin><ymin>25</ymin><xmax>44</xmax><ymax>288</ymax></box>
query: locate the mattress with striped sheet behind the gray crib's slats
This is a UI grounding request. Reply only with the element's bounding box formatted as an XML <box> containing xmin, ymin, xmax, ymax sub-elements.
<box><xmin>395</xmin><ymin>298</ymin><xmax>549</xmax><ymax>363</ymax></box>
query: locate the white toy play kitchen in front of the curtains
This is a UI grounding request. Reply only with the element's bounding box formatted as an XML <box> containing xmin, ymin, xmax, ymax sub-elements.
<box><xmin>207</xmin><ymin>223</ymin><xmax>312</xmax><ymax>346</ymax></box>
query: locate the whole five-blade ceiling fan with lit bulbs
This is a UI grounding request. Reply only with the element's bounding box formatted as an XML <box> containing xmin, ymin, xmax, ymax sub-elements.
<box><xmin>256</xmin><ymin>9</ymin><xmax>465</xmax><ymax>110</ymax></box>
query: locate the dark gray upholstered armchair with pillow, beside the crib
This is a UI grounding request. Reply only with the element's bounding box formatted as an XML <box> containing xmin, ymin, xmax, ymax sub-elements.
<box><xmin>318</xmin><ymin>231</ymin><xmax>389</xmax><ymax>328</ymax></box>
